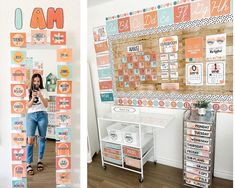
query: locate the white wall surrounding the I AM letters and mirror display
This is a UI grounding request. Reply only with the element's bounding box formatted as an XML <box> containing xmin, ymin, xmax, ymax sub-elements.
<box><xmin>0</xmin><ymin>0</ymin><xmax>80</xmax><ymax>188</ymax></box>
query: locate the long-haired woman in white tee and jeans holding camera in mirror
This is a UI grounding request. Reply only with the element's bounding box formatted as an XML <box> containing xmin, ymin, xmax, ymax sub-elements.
<box><xmin>26</xmin><ymin>74</ymin><xmax>48</xmax><ymax>175</ymax></box>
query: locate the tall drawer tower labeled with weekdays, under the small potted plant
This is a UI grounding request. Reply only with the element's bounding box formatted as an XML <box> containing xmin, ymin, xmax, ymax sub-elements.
<box><xmin>183</xmin><ymin>110</ymin><xmax>216</xmax><ymax>188</ymax></box>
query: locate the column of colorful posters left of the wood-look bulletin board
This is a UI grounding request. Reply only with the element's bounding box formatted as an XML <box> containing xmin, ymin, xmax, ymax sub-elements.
<box><xmin>93</xmin><ymin>26</ymin><xmax>113</xmax><ymax>102</ymax></box>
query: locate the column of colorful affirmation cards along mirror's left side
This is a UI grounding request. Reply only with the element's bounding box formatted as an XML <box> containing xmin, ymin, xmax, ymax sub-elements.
<box><xmin>10</xmin><ymin>33</ymin><xmax>27</xmax><ymax>188</ymax></box>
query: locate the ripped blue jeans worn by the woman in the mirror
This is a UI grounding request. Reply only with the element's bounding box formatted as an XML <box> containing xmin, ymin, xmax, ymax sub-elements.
<box><xmin>26</xmin><ymin>111</ymin><xmax>48</xmax><ymax>164</ymax></box>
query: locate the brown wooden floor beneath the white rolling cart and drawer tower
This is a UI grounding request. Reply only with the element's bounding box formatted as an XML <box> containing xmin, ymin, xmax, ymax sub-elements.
<box><xmin>88</xmin><ymin>155</ymin><xmax>233</xmax><ymax>188</ymax></box>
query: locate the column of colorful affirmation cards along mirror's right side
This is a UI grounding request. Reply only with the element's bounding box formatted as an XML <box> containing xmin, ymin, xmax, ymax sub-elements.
<box><xmin>55</xmin><ymin>47</ymin><xmax>72</xmax><ymax>187</ymax></box>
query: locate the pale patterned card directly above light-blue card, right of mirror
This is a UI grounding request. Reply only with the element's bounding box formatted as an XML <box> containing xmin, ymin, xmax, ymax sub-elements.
<box><xmin>56</xmin><ymin>111</ymin><xmax>71</xmax><ymax>127</ymax></box>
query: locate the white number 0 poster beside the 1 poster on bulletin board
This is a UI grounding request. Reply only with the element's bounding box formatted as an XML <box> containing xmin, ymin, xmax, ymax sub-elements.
<box><xmin>185</xmin><ymin>63</ymin><xmax>203</xmax><ymax>85</ymax></box>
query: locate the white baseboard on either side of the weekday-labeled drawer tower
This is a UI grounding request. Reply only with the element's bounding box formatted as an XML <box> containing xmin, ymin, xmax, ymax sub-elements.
<box><xmin>151</xmin><ymin>157</ymin><xmax>233</xmax><ymax>180</ymax></box>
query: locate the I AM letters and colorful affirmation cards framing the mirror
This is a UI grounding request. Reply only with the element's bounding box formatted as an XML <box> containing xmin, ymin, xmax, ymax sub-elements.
<box><xmin>10</xmin><ymin>7</ymin><xmax>72</xmax><ymax>188</ymax></box>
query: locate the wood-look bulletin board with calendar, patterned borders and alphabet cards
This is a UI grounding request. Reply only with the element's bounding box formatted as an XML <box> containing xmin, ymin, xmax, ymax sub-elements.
<box><xmin>101</xmin><ymin>0</ymin><xmax>233</xmax><ymax>112</ymax></box>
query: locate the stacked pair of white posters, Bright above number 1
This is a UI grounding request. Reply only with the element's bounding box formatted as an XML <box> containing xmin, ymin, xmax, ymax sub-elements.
<box><xmin>206</xmin><ymin>34</ymin><xmax>226</xmax><ymax>85</ymax></box>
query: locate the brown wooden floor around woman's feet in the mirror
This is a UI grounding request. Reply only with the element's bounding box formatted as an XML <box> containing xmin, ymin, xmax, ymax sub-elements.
<box><xmin>27</xmin><ymin>140</ymin><xmax>56</xmax><ymax>188</ymax></box>
